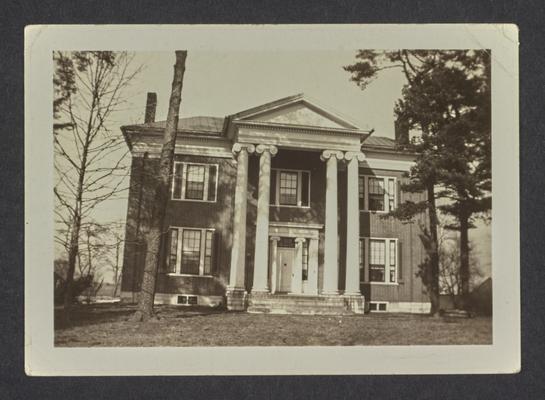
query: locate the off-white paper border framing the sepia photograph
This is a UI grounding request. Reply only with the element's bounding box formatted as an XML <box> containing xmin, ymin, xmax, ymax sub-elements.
<box><xmin>25</xmin><ymin>24</ymin><xmax>520</xmax><ymax>376</ymax></box>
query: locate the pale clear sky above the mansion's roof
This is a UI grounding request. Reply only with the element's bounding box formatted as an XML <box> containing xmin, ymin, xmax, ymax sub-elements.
<box><xmin>73</xmin><ymin>49</ymin><xmax>490</xmax><ymax>284</ymax></box>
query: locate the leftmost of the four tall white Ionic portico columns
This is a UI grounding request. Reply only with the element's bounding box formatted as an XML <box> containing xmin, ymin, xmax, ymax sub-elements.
<box><xmin>227</xmin><ymin>143</ymin><xmax>255</xmax><ymax>310</ymax></box>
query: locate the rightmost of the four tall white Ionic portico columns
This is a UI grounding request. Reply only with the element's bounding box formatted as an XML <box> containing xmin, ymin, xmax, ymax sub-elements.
<box><xmin>344</xmin><ymin>152</ymin><xmax>365</xmax><ymax>296</ymax></box>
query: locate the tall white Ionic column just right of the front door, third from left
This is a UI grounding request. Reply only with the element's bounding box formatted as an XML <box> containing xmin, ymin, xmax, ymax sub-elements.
<box><xmin>321</xmin><ymin>150</ymin><xmax>343</xmax><ymax>294</ymax></box>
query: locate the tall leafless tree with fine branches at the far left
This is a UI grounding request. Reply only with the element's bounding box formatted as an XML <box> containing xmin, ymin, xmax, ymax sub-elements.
<box><xmin>53</xmin><ymin>51</ymin><xmax>141</xmax><ymax>320</ymax></box>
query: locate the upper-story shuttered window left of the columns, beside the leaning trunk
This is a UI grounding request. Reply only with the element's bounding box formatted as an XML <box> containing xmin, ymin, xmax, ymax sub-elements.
<box><xmin>172</xmin><ymin>162</ymin><xmax>218</xmax><ymax>201</ymax></box>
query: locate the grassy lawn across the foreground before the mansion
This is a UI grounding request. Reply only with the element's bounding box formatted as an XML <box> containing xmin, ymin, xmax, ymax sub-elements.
<box><xmin>55</xmin><ymin>304</ymin><xmax>492</xmax><ymax>347</ymax></box>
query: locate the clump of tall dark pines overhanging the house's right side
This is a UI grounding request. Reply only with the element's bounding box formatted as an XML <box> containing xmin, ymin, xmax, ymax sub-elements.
<box><xmin>345</xmin><ymin>50</ymin><xmax>491</xmax><ymax>314</ymax></box>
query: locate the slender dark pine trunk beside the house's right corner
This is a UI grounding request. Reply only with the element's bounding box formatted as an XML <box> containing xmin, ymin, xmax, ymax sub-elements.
<box><xmin>427</xmin><ymin>184</ymin><xmax>439</xmax><ymax>316</ymax></box>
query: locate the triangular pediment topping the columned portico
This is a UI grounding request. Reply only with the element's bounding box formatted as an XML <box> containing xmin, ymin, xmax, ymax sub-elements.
<box><xmin>232</xmin><ymin>95</ymin><xmax>358</xmax><ymax>129</ymax></box>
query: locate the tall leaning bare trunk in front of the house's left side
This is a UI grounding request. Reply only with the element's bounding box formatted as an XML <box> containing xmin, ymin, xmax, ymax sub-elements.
<box><xmin>133</xmin><ymin>51</ymin><xmax>187</xmax><ymax>321</ymax></box>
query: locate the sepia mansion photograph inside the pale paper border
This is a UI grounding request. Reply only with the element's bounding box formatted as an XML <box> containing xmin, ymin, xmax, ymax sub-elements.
<box><xmin>27</xmin><ymin>27</ymin><xmax>519</xmax><ymax>373</ymax></box>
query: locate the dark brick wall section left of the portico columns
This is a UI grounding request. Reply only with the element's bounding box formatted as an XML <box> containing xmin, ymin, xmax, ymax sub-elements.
<box><xmin>122</xmin><ymin>155</ymin><xmax>236</xmax><ymax>295</ymax></box>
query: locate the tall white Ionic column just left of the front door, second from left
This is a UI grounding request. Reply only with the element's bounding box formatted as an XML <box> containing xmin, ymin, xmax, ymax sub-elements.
<box><xmin>252</xmin><ymin>144</ymin><xmax>278</xmax><ymax>292</ymax></box>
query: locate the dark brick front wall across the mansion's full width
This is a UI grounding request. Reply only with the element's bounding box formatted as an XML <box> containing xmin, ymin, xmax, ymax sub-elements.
<box><xmin>122</xmin><ymin>149</ymin><xmax>428</xmax><ymax>302</ymax></box>
